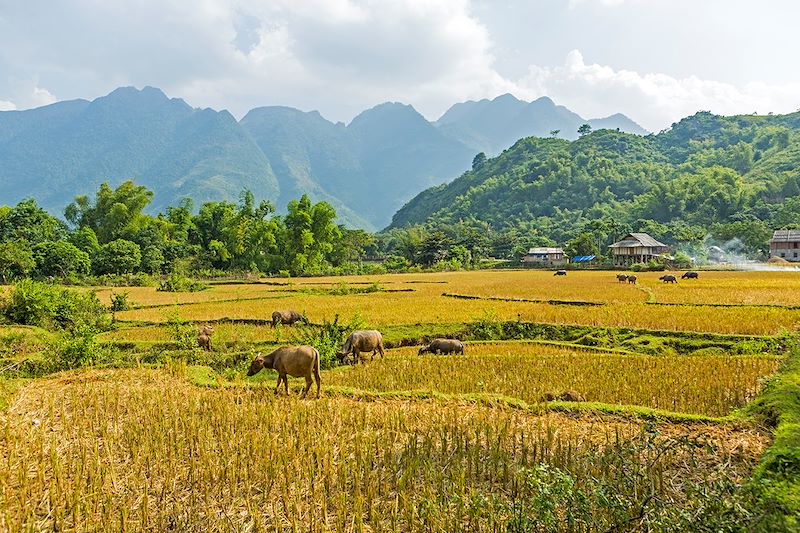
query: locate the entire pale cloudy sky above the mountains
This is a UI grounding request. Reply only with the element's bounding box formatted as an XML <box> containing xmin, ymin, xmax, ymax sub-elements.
<box><xmin>0</xmin><ymin>0</ymin><xmax>800</xmax><ymax>131</ymax></box>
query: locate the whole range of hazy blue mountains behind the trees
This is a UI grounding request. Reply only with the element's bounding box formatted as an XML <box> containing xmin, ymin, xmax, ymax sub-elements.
<box><xmin>0</xmin><ymin>87</ymin><xmax>646</xmax><ymax>229</ymax></box>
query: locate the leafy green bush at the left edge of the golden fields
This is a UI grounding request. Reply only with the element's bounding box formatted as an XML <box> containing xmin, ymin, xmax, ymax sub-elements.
<box><xmin>2</xmin><ymin>280</ymin><xmax>108</xmax><ymax>329</ymax></box>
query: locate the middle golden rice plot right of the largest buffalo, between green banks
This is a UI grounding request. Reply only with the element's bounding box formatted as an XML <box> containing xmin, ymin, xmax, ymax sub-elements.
<box><xmin>325</xmin><ymin>343</ymin><xmax>780</xmax><ymax>416</ymax></box>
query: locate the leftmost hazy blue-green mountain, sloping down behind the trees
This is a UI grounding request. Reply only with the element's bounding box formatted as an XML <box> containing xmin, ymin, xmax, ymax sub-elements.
<box><xmin>0</xmin><ymin>87</ymin><xmax>278</xmax><ymax>212</ymax></box>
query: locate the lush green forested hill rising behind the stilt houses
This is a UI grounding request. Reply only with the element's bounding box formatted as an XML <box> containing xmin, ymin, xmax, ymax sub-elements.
<box><xmin>390</xmin><ymin>112</ymin><xmax>800</xmax><ymax>249</ymax></box>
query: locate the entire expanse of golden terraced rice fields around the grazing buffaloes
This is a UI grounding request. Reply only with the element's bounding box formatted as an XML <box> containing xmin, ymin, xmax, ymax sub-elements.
<box><xmin>0</xmin><ymin>271</ymin><xmax>800</xmax><ymax>531</ymax></box>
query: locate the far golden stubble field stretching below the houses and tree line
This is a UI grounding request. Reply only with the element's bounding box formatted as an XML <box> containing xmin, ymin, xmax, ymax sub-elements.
<box><xmin>100</xmin><ymin>271</ymin><xmax>800</xmax><ymax>335</ymax></box>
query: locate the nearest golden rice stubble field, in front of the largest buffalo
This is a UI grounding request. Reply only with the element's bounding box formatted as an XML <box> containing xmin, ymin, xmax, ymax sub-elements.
<box><xmin>0</xmin><ymin>370</ymin><xmax>768</xmax><ymax>532</ymax></box>
